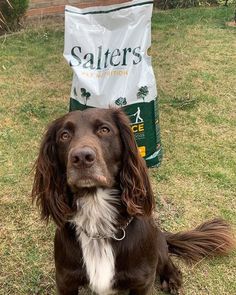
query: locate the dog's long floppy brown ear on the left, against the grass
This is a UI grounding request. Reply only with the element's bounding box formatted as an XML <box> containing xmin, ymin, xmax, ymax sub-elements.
<box><xmin>32</xmin><ymin>118</ymin><xmax>70</xmax><ymax>226</ymax></box>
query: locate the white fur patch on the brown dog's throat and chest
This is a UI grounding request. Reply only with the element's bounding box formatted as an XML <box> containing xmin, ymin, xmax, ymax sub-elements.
<box><xmin>73</xmin><ymin>189</ymin><xmax>118</xmax><ymax>295</ymax></box>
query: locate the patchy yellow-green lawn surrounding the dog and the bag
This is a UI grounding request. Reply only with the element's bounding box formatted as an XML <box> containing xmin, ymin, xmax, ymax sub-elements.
<box><xmin>0</xmin><ymin>7</ymin><xmax>236</xmax><ymax>295</ymax></box>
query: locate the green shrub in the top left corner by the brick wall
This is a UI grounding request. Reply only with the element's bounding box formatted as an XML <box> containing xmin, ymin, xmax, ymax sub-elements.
<box><xmin>0</xmin><ymin>0</ymin><xmax>29</xmax><ymax>31</ymax></box>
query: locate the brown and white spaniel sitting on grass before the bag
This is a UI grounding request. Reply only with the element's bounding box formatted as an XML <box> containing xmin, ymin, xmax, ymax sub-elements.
<box><xmin>32</xmin><ymin>109</ymin><xmax>234</xmax><ymax>295</ymax></box>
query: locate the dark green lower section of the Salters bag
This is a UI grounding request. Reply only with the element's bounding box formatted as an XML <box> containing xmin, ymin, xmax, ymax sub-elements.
<box><xmin>70</xmin><ymin>98</ymin><xmax>163</xmax><ymax>167</ymax></box>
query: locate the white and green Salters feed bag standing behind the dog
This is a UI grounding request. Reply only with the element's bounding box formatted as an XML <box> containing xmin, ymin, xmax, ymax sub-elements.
<box><xmin>64</xmin><ymin>1</ymin><xmax>162</xmax><ymax>167</ymax></box>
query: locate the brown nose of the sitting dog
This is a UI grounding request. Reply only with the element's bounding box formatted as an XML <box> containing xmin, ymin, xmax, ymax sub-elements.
<box><xmin>71</xmin><ymin>147</ymin><xmax>96</xmax><ymax>168</ymax></box>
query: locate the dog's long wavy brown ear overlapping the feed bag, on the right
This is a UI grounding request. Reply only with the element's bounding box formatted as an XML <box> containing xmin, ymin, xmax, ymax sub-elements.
<box><xmin>113</xmin><ymin>109</ymin><xmax>155</xmax><ymax>216</ymax></box>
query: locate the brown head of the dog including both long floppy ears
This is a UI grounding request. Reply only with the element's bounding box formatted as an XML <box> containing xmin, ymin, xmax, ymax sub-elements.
<box><xmin>32</xmin><ymin>109</ymin><xmax>154</xmax><ymax>226</ymax></box>
